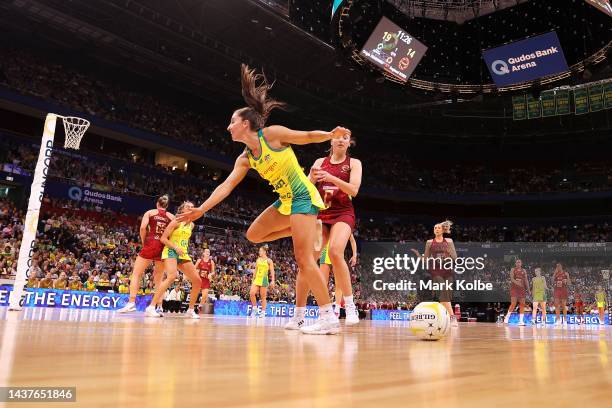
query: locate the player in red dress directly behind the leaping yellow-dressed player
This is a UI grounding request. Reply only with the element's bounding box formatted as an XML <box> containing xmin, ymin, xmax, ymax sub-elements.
<box><xmin>285</xmin><ymin>134</ymin><xmax>362</xmax><ymax>330</ymax></box>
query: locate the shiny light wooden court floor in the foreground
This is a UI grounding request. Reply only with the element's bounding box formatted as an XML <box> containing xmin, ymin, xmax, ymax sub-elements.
<box><xmin>0</xmin><ymin>308</ymin><xmax>612</xmax><ymax>408</ymax></box>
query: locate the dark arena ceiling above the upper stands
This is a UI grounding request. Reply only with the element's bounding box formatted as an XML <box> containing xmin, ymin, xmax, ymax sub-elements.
<box><xmin>0</xmin><ymin>0</ymin><xmax>611</xmax><ymax>136</ymax></box>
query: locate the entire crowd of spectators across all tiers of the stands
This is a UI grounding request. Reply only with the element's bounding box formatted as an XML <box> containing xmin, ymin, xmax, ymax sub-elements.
<box><xmin>0</xmin><ymin>46</ymin><xmax>612</xmax><ymax>309</ymax></box>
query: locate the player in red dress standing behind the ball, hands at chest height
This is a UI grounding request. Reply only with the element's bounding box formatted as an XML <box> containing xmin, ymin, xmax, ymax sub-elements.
<box><xmin>412</xmin><ymin>220</ymin><xmax>458</xmax><ymax>327</ymax></box>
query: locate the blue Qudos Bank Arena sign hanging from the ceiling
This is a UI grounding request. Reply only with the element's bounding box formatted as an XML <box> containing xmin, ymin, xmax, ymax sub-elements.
<box><xmin>482</xmin><ymin>31</ymin><xmax>568</xmax><ymax>87</ymax></box>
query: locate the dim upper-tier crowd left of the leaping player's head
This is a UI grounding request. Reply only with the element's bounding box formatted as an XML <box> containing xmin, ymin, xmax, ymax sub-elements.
<box><xmin>0</xmin><ymin>46</ymin><xmax>236</xmax><ymax>154</ymax></box>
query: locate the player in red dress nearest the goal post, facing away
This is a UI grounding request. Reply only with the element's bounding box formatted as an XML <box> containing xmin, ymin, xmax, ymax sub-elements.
<box><xmin>117</xmin><ymin>195</ymin><xmax>174</xmax><ymax>313</ymax></box>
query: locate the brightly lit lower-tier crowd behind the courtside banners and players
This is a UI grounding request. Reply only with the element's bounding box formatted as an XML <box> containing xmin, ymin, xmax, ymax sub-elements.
<box><xmin>0</xmin><ymin>194</ymin><xmax>609</xmax><ymax>309</ymax></box>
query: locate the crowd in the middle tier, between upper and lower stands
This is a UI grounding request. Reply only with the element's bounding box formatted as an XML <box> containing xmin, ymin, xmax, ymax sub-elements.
<box><xmin>0</xmin><ymin>131</ymin><xmax>612</xmax><ymax>242</ymax></box>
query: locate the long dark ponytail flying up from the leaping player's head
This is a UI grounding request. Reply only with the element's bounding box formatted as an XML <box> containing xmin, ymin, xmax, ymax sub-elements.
<box><xmin>236</xmin><ymin>64</ymin><xmax>286</xmax><ymax>130</ymax></box>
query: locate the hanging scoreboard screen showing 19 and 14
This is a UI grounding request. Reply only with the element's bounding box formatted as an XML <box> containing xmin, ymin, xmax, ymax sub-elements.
<box><xmin>361</xmin><ymin>17</ymin><xmax>427</xmax><ymax>81</ymax></box>
